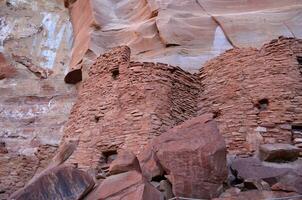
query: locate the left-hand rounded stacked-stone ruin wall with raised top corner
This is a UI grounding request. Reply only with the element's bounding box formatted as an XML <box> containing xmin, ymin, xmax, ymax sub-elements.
<box><xmin>65</xmin><ymin>47</ymin><xmax>199</xmax><ymax>171</ymax></box>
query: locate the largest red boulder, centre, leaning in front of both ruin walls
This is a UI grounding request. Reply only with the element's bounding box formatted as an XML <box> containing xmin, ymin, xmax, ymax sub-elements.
<box><xmin>140</xmin><ymin>114</ymin><xmax>227</xmax><ymax>198</ymax></box>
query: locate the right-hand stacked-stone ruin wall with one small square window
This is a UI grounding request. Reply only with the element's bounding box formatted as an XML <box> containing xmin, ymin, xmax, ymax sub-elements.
<box><xmin>199</xmin><ymin>37</ymin><xmax>302</xmax><ymax>154</ymax></box>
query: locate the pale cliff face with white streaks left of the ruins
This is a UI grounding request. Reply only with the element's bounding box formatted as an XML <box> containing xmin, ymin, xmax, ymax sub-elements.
<box><xmin>0</xmin><ymin>0</ymin><xmax>76</xmax><ymax>199</ymax></box>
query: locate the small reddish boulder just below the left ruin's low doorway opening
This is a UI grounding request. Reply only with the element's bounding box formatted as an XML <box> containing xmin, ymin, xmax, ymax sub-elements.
<box><xmin>109</xmin><ymin>150</ymin><xmax>141</xmax><ymax>175</ymax></box>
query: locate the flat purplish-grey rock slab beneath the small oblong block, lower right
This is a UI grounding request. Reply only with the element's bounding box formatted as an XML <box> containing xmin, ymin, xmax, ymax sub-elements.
<box><xmin>230</xmin><ymin>155</ymin><xmax>302</xmax><ymax>195</ymax></box>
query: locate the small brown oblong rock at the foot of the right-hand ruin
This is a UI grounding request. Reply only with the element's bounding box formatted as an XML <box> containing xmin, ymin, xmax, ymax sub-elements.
<box><xmin>259</xmin><ymin>143</ymin><xmax>301</xmax><ymax>162</ymax></box>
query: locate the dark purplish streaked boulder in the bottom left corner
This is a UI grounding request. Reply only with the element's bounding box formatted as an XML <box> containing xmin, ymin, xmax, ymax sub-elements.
<box><xmin>10</xmin><ymin>165</ymin><xmax>94</xmax><ymax>200</ymax></box>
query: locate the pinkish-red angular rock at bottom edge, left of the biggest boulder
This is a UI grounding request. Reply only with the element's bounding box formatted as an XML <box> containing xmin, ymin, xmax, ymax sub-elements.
<box><xmin>86</xmin><ymin>170</ymin><xmax>163</xmax><ymax>200</ymax></box>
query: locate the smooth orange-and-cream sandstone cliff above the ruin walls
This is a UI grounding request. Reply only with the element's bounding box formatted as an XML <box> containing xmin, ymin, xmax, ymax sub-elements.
<box><xmin>65</xmin><ymin>0</ymin><xmax>302</xmax><ymax>81</ymax></box>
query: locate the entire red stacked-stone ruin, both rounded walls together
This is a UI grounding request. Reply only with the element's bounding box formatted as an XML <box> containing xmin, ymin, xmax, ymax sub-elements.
<box><xmin>65</xmin><ymin>37</ymin><xmax>302</xmax><ymax>168</ymax></box>
